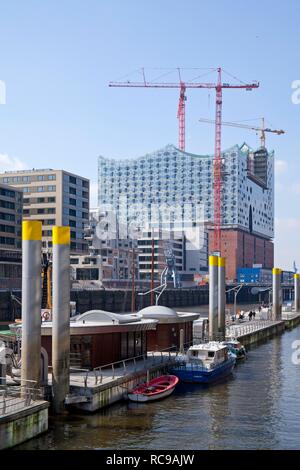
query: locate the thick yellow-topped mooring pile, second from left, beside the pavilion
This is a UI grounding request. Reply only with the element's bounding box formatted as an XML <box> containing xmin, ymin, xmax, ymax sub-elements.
<box><xmin>52</xmin><ymin>227</ymin><xmax>70</xmax><ymax>414</ymax></box>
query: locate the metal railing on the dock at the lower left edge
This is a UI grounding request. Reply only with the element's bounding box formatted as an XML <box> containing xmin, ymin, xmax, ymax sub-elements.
<box><xmin>0</xmin><ymin>377</ymin><xmax>44</xmax><ymax>416</ymax></box>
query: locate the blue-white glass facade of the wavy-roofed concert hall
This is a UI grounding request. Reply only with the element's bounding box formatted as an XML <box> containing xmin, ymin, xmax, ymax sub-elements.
<box><xmin>98</xmin><ymin>144</ymin><xmax>274</xmax><ymax>238</ymax></box>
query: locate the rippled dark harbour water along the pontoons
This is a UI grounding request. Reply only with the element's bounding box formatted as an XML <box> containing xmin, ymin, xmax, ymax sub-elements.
<box><xmin>18</xmin><ymin>326</ymin><xmax>300</xmax><ymax>449</ymax></box>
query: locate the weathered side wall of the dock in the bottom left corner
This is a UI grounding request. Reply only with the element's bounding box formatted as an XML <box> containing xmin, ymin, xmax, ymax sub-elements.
<box><xmin>0</xmin><ymin>402</ymin><xmax>49</xmax><ymax>450</ymax></box>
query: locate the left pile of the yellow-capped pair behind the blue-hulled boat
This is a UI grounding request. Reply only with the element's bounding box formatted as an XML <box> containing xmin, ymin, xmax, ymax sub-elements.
<box><xmin>208</xmin><ymin>256</ymin><xmax>218</xmax><ymax>341</ymax></box>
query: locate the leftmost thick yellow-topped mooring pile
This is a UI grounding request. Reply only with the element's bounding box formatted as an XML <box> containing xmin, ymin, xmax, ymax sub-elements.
<box><xmin>21</xmin><ymin>220</ymin><xmax>42</xmax><ymax>387</ymax></box>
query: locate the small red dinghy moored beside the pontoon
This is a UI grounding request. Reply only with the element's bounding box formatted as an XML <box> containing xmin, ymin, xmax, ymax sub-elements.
<box><xmin>128</xmin><ymin>375</ymin><xmax>179</xmax><ymax>402</ymax></box>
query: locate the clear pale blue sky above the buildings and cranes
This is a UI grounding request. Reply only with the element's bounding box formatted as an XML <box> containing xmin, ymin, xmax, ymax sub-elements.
<box><xmin>0</xmin><ymin>0</ymin><xmax>300</xmax><ymax>269</ymax></box>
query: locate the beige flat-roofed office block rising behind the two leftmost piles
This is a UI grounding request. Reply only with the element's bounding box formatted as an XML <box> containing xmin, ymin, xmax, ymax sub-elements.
<box><xmin>0</xmin><ymin>169</ymin><xmax>90</xmax><ymax>252</ymax></box>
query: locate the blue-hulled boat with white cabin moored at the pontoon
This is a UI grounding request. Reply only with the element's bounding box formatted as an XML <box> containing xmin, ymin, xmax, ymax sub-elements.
<box><xmin>170</xmin><ymin>341</ymin><xmax>236</xmax><ymax>384</ymax></box>
